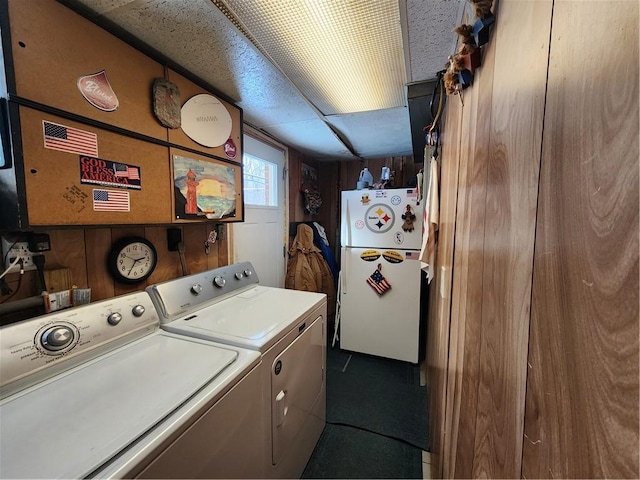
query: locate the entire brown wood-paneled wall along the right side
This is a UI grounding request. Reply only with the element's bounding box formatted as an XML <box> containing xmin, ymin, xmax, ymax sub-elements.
<box><xmin>427</xmin><ymin>0</ymin><xmax>640</xmax><ymax>478</ymax></box>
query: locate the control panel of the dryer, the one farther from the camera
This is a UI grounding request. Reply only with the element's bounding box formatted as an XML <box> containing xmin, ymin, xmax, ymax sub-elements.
<box><xmin>147</xmin><ymin>262</ymin><xmax>259</xmax><ymax>323</ymax></box>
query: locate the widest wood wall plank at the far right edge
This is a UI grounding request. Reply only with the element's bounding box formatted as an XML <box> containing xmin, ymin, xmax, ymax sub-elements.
<box><xmin>522</xmin><ymin>0</ymin><xmax>639</xmax><ymax>478</ymax></box>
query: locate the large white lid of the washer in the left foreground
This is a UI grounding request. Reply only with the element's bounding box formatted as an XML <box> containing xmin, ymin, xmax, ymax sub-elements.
<box><xmin>0</xmin><ymin>332</ymin><xmax>238</xmax><ymax>478</ymax></box>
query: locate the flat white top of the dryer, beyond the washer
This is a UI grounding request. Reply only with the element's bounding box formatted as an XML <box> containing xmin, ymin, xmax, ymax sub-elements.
<box><xmin>163</xmin><ymin>285</ymin><xmax>326</xmax><ymax>352</ymax></box>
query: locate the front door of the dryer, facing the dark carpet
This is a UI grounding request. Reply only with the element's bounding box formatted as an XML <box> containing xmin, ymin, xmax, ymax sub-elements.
<box><xmin>271</xmin><ymin>316</ymin><xmax>324</xmax><ymax>465</ymax></box>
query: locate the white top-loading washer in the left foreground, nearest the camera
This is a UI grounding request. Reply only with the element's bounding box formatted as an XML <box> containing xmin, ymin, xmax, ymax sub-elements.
<box><xmin>0</xmin><ymin>292</ymin><xmax>264</xmax><ymax>478</ymax></box>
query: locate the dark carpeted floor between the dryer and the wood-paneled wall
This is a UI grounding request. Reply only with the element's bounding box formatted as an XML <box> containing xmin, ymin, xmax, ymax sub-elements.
<box><xmin>303</xmin><ymin>345</ymin><xmax>429</xmax><ymax>478</ymax></box>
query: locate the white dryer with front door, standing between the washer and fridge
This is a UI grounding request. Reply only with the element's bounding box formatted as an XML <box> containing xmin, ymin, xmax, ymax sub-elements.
<box><xmin>147</xmin><ymin>262</ymin><xmax>327</xmax><ymax>478</ymax></box>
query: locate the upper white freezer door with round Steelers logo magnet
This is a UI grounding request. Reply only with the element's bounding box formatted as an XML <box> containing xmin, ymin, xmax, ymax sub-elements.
<box><xmin>340</xmin><ymin>188</ymin><xmax>423</xmax><ymax>250</ymax></box>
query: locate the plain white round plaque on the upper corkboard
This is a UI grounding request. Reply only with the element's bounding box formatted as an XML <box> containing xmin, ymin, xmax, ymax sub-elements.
<box><xmin>181</xmin><ymin>93</ymin><xmax>232</xmax><ymax>147</ymax></box>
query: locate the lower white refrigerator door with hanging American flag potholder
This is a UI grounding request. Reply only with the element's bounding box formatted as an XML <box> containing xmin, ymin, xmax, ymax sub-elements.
<box><xmin>340</xmin><ymin>248</ymin><xmax>420</xmax><ymax>363</ymax></box>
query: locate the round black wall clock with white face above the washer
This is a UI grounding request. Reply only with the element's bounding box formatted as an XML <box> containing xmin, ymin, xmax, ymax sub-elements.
<box><xmin>107</xmin><ymin>237</ymin><xmax>158</xmax><ymax>283</ymax></box>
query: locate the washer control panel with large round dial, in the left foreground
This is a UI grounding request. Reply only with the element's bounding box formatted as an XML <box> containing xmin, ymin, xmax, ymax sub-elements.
<box><xmin>0</xmin><ymin>292</ymin><xmax>159</xmax><ymax>394</ymax></box>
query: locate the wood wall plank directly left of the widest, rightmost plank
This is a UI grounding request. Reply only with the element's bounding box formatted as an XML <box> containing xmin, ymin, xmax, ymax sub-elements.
<box><xmin>471</xmin><ymin>0</ymin><xmax>552</xmax><ymax>478</ymax></box>
